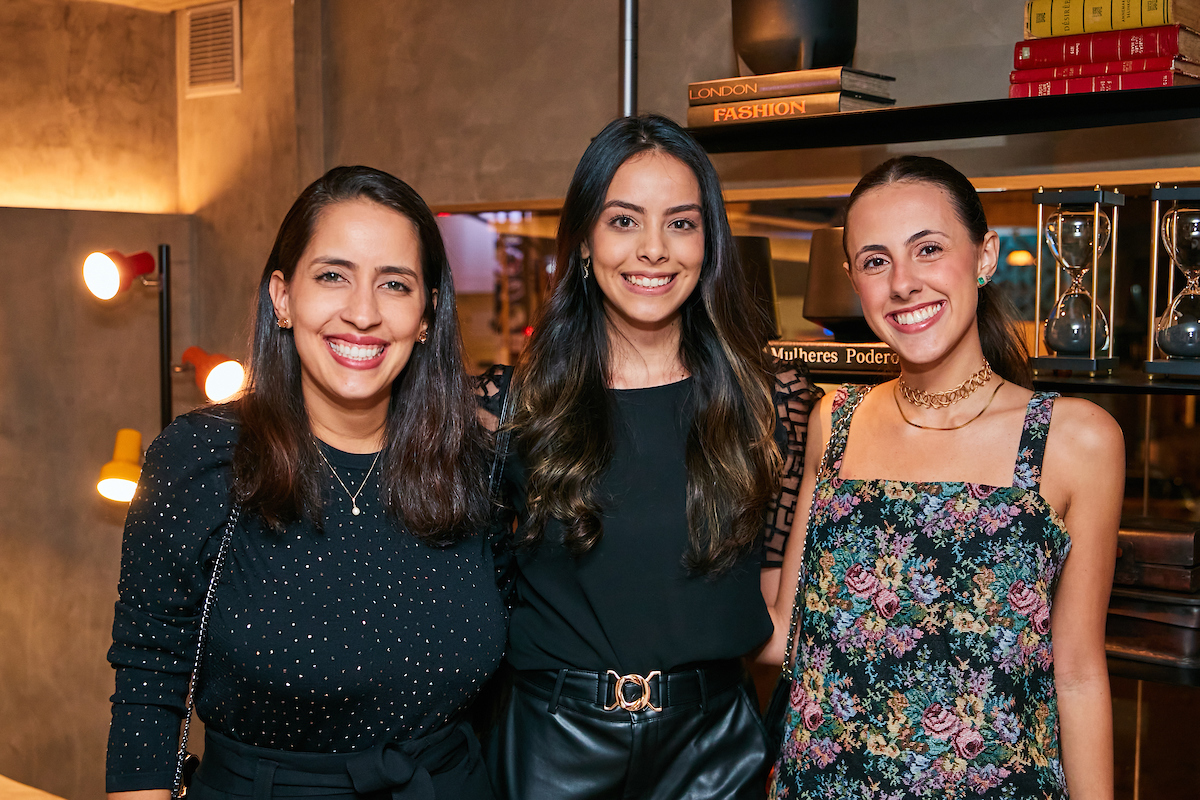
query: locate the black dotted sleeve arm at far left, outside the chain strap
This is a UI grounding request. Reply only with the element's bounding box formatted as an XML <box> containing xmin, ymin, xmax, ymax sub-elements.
<box><xmin>106</xmin><ymin>414</ymin><xmax>236</xmax><ymax>794</ymax></box>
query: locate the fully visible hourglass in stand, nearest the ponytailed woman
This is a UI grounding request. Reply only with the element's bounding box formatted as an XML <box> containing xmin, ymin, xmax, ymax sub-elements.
<box><xmin>1031</xmin><ymin>186</ymin><xmax>1124</xmax><ymax>375</ymax></box>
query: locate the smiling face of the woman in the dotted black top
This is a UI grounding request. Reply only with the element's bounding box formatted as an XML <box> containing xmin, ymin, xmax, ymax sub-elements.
<box><xmin>270</xmin><ymin>199</ymin><xmax>428</xmax><ymax>427</ymax></box>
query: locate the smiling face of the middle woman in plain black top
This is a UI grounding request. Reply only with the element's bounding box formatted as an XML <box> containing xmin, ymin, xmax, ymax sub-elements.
<box><xmin>582</xmin><ymin>150</ymin><xmax>704</xmax><ymax>341</ymax></box>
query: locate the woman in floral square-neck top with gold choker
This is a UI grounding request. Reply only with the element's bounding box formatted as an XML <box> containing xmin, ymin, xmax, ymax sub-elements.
<box><xmin>763</xmin><ymin>156</ymin><xmax>1124</xmax><ymax>800</ymax></box>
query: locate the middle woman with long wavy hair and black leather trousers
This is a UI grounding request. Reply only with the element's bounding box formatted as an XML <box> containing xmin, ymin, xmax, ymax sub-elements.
<box><xmin>485</xmin><ymin>115</ymin><xmax>814</xmax><ymax>800</ymax></box>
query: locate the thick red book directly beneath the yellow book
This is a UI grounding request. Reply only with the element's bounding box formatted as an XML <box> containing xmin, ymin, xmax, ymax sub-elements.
<box><xmin>1013</xmin><ymin>25</ymin><xmax>1200</xmax><ymax>70</ymax></box>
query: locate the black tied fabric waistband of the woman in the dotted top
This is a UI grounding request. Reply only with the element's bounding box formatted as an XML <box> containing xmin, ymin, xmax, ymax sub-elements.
<box><xmin>193</xmin><ymin>722</ymin><xmax>486</xmax><ymax>800</ymax></box>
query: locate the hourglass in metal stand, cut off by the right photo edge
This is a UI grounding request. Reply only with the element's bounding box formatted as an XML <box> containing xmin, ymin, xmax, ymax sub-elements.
<box><xmin>1142</xmin><ymin>184</ymin><xmax>1200</xmax><ymax>378</ymax></box>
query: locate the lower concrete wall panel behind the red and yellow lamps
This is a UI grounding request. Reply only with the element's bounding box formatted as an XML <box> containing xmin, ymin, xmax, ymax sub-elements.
<box><xmin>0</xmin><ymin>209</ymin><xmax>199</xmax><ymax>799</ymax></box>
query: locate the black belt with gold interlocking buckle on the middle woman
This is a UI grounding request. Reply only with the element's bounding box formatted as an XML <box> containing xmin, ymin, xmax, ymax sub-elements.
<box><xmin>515</xmin><ymin>658</ymin><xmax>744</xmax><ymax>714</ymax></box>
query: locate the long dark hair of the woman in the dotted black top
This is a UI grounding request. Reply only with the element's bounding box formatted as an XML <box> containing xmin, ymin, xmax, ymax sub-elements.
<box><xmin>233</xmin><ymin>167</ymin><xmax>490</xmax><ymax>545</ymax></box>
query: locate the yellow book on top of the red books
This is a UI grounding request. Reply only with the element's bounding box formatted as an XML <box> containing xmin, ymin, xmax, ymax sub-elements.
<box><xmin>1025</xmin><ymin>0</ymin><xmax>1200</xmax><ymax>38</ymax></box>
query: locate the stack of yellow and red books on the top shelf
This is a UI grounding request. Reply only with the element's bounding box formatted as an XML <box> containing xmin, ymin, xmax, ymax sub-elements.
<box><xmin>1008</xmin><ymin>0</ymin><xmax>1200</xmax><ymax>97</ymax></box>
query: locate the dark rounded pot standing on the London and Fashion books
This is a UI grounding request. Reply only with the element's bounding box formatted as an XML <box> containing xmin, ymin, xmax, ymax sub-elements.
<box><xmin>732</xmin><ymin>0</ymin><xmax>858</xmax><ymax>74</ymax></box>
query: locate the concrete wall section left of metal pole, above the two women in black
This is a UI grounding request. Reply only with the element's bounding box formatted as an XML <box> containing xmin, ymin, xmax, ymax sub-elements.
<box><xmin>325</xmin><ymin>0</ymin><xmax>618</xmax><ymax>204</ymax></box>
